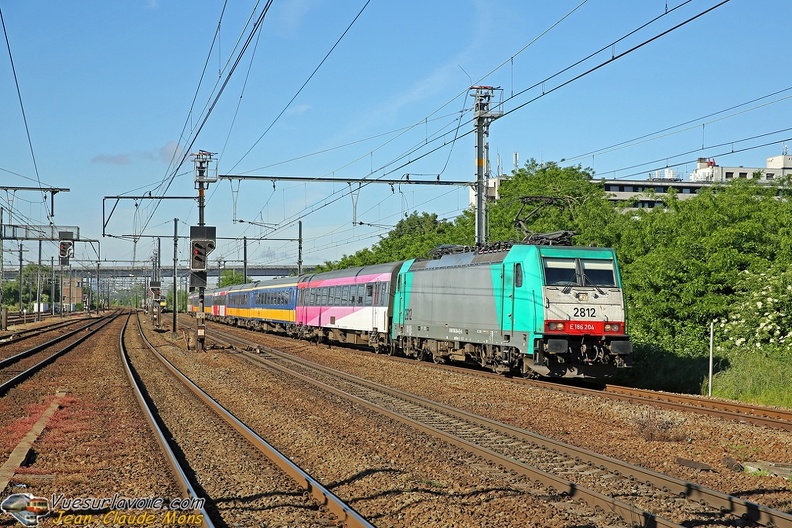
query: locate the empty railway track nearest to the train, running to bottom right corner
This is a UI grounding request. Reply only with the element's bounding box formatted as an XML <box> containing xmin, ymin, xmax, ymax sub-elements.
<box><xmin>207</xmin><ymin>331</ymin><xmax>792</xmax><ymax>526</ymax></box>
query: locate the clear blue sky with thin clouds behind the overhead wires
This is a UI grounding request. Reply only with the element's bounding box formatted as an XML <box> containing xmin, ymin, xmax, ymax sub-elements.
<box><xmin>0</xmin><ymin>0</ymin><xmax>792</xmax><ymax>269</ymax></box>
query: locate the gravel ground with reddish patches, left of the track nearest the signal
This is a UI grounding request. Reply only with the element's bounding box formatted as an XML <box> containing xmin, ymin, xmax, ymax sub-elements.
<box><xmin>0</xmin><ymin>318</ymin><xmax>178</xmax><ymax>526</ymax></box>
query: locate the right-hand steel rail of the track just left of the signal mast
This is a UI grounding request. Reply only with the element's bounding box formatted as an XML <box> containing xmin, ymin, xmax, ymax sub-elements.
<box><xmin>134</xmin><ymin>318</ymin><xmax>374</xmax><ymax>528</ymax></box>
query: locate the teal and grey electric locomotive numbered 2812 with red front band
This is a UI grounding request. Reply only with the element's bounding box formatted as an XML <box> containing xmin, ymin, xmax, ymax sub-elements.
<box><xmin>391</xmin><ymin>245</ymin><xmax>632</xmax><ymax>378</ymax></box>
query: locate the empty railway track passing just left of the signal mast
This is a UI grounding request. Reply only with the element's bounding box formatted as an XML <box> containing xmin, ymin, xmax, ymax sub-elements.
<box><xmin>127</xmin><ymin>312</ymin><xmax>371</xmax><ymax>527</ymax></box>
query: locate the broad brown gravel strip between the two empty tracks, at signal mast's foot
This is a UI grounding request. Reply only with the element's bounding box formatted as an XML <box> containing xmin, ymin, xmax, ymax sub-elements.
<box><xmin>155</xmin><ymin>318</ymin><xmax>625</xmax><ymax>527</ymax></box>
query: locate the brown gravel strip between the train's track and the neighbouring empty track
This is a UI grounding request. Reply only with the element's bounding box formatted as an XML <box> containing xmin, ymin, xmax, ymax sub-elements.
<box><xmin>240</xmin><ymin>328</ymin><xmax>792</xmax><ymax>512</ymax></box>
